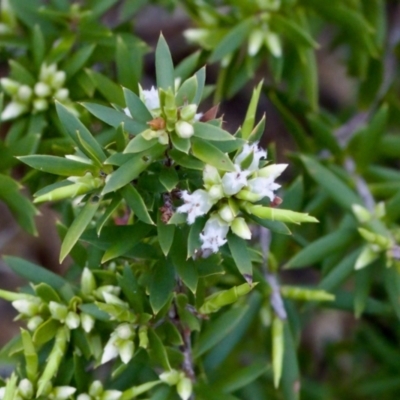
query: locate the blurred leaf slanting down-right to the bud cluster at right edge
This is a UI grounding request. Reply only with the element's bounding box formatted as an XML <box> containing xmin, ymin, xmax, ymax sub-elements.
<box><xmin>300</xmin><ymin>155</ymin><xmax>362</xmax><ymax>210</ymax></box>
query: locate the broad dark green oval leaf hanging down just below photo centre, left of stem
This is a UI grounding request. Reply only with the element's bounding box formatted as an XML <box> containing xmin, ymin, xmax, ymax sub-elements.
<box><xmin>149</xmin><ymin>259</ymin><xmax>175</xmax><ymax>314</ymax></box>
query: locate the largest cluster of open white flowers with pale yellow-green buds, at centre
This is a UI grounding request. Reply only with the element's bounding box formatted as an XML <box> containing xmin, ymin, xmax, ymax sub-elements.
<box><xmin>177</xmin><ymin>143</ymin><xmax>287</xmax><ymax>253</ymax></box>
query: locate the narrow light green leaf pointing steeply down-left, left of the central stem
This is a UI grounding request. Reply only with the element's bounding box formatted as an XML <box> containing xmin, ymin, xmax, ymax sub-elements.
<box><xmin>60</xmin><ymin>199</ymin><xmax>100</xmax><ymax>263</ymax></box>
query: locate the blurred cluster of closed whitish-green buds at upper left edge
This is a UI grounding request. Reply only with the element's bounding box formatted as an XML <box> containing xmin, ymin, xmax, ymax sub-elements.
<box><xmin>0</xmin><ymin>64</ymin><xmax>69</xmax><ymax>121</ymax></box>
